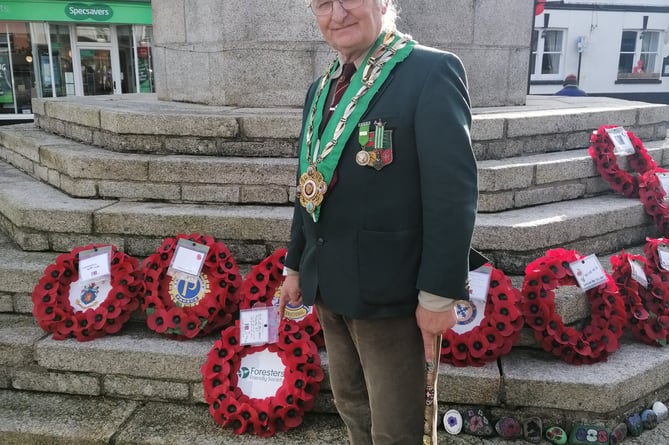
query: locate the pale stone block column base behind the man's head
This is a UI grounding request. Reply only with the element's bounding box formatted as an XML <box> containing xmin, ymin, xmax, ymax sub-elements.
<box><xmin>152</xmin><ymin>0</ymin><xmax>533</xmax><ymax>108</ymax></box>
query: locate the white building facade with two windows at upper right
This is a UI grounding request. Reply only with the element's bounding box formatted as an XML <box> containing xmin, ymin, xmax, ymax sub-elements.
<box><xmin>529</xmin><ymin>0</ymin><xmax>669</xmax><ymax>104</ymax></box>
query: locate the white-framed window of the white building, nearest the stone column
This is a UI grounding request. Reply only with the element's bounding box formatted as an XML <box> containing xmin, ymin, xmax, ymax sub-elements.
<box><xmin>530</xmin><ymin>29</ymin><xmax>565</xmax><ymax>80</ymax></box>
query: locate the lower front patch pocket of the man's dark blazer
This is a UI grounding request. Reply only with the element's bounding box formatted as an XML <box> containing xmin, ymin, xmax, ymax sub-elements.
<box><xmin>358</xmin><ymin>230</ymin><xmax>422</xmax><ymax>305</ymax></box>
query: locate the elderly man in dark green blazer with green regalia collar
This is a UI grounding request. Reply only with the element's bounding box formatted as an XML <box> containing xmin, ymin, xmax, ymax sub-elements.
<box><xmin>279</xmin><ymin>0</ymin><xmax>478</xmax><ymax>445</ymax></box>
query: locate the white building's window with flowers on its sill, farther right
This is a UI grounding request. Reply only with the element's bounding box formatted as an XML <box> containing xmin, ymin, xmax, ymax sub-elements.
<box><xmin>618</xmin><ymin>31</ymin><xmax>661</xmax><ymax>79</ymax></box>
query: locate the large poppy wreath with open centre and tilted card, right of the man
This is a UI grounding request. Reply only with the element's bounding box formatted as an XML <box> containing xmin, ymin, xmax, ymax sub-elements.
<box><xmin>520</xmin><ymin>248</ymin><xmax>626</xmax><ymax>365</ymax></box>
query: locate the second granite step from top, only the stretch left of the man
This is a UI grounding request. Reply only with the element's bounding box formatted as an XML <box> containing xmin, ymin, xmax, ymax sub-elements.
<box><xmin>0</xmin><ymin>124</ymin><xmax>297</xmax><ymax>205</ymax></box>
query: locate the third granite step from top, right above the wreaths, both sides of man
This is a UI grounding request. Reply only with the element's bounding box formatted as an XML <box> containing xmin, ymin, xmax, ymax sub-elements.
<box><xmin>0</xmin><ymin>161</ymin><xmax>657</xmax><ymax>274</ymax></box>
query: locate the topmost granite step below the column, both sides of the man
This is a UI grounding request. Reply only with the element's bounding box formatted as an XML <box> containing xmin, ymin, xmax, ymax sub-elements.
<box><xmin>33</xmin><ymin>94</ymin><xmax>669</xmax><ymax>160</ymax></box>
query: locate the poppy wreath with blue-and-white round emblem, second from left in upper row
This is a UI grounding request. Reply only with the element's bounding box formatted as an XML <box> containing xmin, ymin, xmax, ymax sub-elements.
<box><xmin>140</xmin><ymin>234</ymin><xmax>242</xmax><ymax>340</ymax></box>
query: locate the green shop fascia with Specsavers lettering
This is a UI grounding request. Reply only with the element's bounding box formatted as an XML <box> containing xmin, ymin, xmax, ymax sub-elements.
<box><xmin>0</xmin><ymin>0</ymin><xmax>152</xmax><ymax>25</ymax></box>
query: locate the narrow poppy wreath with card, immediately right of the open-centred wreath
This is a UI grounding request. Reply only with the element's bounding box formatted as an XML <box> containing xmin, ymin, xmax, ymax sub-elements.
<box><xmin>611</xmin><ymin>246</ymin><xmax>669</xmax><ymax>346</ymax></box>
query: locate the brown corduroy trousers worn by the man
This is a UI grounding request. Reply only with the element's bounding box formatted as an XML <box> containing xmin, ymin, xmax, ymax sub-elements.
<box><xmin>316</xmin><ymin>299</ymin><xmax>425</xmax><ymax>445</ymax></box>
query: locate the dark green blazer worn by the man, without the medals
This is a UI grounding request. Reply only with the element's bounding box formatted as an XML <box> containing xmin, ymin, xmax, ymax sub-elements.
<box><xmin>285</xmin><ymin>45</ymin><xmax>478</xmax><ymax>318</ymax></box>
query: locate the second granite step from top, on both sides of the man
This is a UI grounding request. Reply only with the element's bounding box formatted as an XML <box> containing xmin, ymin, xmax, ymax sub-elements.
<box><xmin>5</xmin><ymin>124</ymin><xmax>669</xmax><ymax>213</ymax></box>
